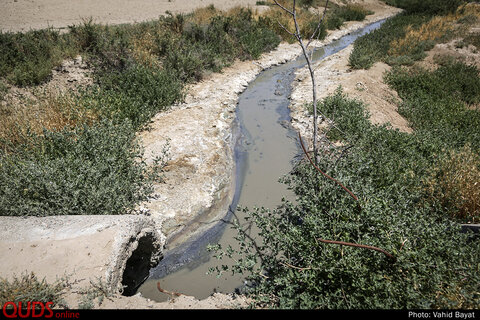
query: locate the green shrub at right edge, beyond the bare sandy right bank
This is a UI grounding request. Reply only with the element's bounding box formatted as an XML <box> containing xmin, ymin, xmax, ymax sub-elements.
<box><xmin>385</xmin><ymin>62</ymin><xmax>480</xmax><ymax>151</ymax></box>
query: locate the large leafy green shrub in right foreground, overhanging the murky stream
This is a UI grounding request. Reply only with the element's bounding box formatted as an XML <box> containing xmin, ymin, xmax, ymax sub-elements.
<box><xmin>211</xmin><ymin>92</ymin><xmax>480</xmax><ymax>309</ymax></box>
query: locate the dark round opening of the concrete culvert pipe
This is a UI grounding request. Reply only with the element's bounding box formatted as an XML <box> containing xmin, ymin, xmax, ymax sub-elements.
<box><xmin>122</xmin><ymin>233</ymin><xmax>160</xmax><ymax>297</ymax></box>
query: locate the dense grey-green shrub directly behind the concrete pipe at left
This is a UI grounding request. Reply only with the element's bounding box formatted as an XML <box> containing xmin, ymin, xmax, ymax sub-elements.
<box><xmin>0</xmin><ymin>121</ymin><xmax>164</xmax><ymax>216</ymax></box>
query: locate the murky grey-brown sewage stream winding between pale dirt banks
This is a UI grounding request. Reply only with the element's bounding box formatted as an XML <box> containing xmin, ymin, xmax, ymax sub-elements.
<box><xmin>138</xmin><ymin>20</ymin><xmax>384</xmax><ymax>301</ymax></box>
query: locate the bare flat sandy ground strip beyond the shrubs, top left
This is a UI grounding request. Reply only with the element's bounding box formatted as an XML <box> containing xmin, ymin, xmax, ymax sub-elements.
<box><xmin>0</xmin><ymin>0</ymin><xmax>262</xmax><ymax>31</ymax></box>
